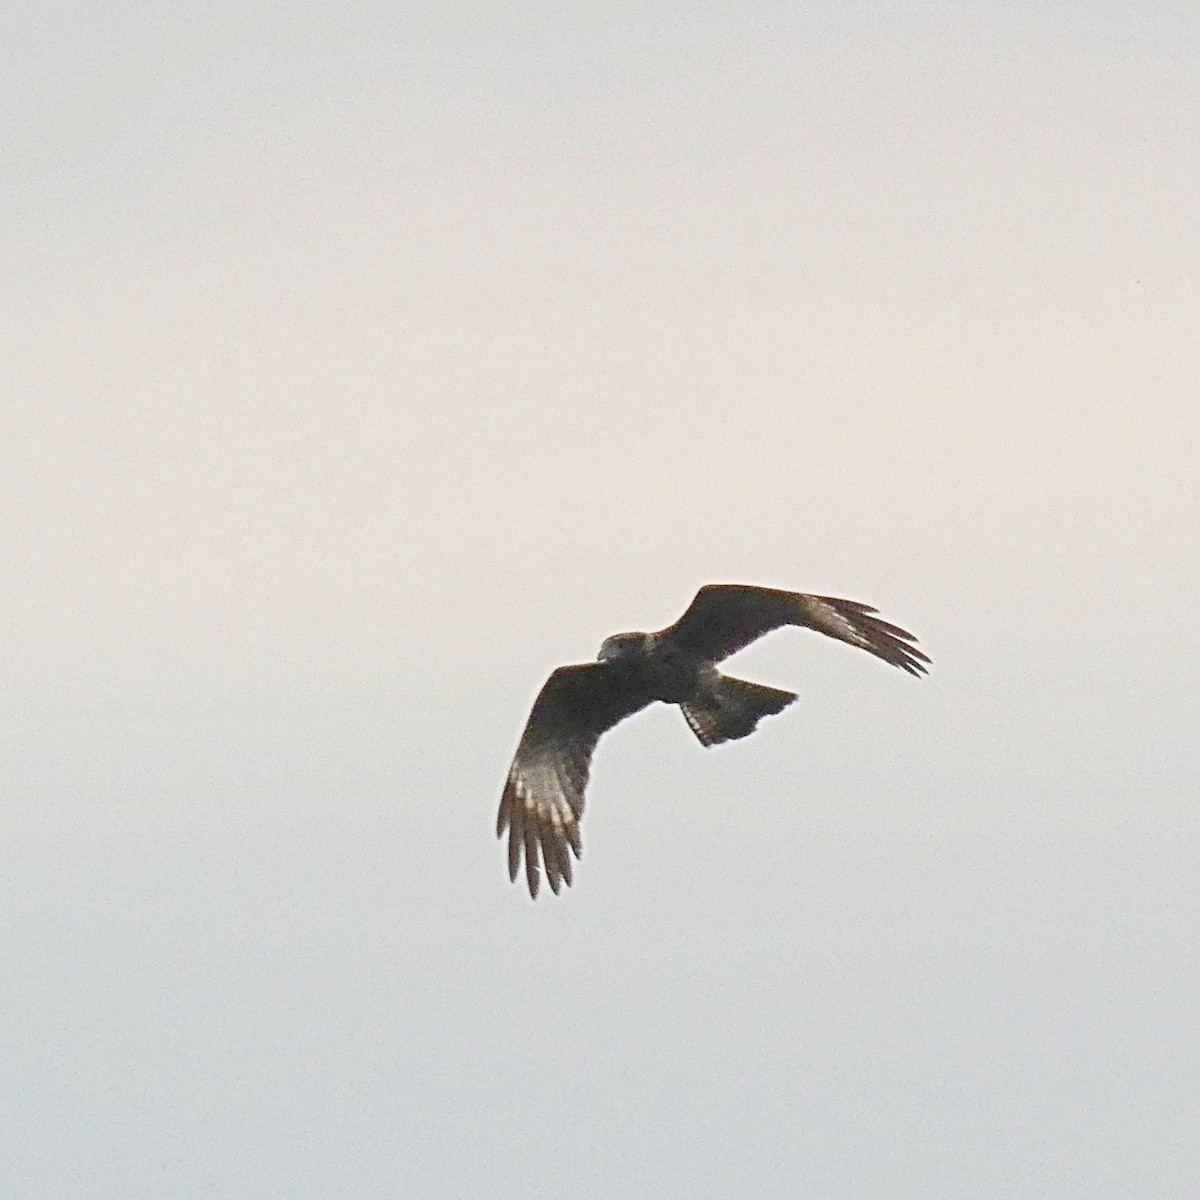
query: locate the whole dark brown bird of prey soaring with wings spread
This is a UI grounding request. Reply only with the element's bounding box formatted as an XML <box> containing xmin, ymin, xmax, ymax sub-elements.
<box><xmin>496</xmin><ymin>583</ymin><xmax>929</xmax><ymax>898</ymax></box>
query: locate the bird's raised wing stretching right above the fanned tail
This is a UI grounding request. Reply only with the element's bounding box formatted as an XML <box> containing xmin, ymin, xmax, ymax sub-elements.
<box><xmin>658</xmin><ymin>583</ymin><xmax>929</xmax><ymax>674</ymax></box>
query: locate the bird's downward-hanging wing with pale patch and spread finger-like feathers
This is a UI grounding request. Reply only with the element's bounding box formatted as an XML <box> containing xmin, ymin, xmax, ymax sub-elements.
<box><xmin>496</xmin><ymin>662</ymin><xmax>654</xmax><ymax>896</ymax></box>
